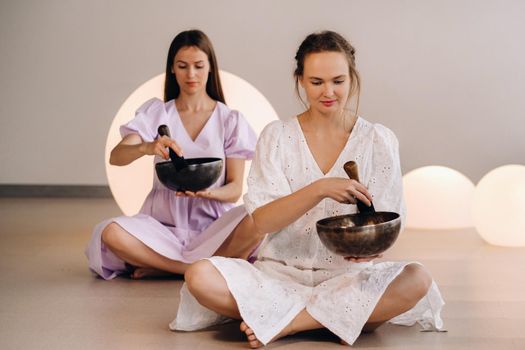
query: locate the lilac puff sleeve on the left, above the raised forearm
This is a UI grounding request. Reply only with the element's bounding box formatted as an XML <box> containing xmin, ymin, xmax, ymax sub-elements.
<box><xmin>120</xmin><ymin>98</ymin><xmax>167</xmax><ymax>142</ymax></box>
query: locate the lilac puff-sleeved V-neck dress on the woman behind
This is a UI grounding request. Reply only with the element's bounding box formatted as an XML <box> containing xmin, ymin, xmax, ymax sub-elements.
<box><xmin>86</xmin><ymin>99</ymin><xmax>257</xmax><ymax>279</ymax></box>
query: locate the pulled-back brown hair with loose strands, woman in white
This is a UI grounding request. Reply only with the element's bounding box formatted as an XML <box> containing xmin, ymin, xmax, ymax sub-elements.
<box><xmin>293</xmin><ymin>30</ymin><xmax>361</xmax><ymax>113</ymax></box>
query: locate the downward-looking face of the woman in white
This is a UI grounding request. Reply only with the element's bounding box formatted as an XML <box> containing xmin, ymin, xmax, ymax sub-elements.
<box><xmin>300</xmin><ymin>51</ymin><xmax>350</xmax><ymax>114</ymax></box>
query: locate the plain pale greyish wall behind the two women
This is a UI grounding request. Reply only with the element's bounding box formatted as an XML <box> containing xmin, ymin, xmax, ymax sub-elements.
<box><xmin>0</xmin><ymin>0</ymin><xmax>525</xmax><ymax>185</ymax></box>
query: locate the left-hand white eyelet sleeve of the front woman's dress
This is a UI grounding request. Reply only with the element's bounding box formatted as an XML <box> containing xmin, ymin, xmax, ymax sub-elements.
<box><xmin>244</xmin><ymin>120</ymin><xmax>292</xmax><ymax>215</ymax></box>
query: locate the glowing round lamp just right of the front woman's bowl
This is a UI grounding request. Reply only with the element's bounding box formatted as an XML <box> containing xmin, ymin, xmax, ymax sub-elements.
<box><xmin>403</xmin><ymin>166</ymin><xmax>475</xmax><ymax>229</ymax></box>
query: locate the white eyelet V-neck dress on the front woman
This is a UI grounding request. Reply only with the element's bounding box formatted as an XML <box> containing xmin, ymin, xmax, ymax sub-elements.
<box><xmin>170</xmin><ymin>118</ymin><xmax>444</xmax><ymax>345</ymax></box>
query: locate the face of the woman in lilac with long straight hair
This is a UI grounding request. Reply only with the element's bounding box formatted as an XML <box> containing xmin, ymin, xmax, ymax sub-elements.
<box><xmin>172</xmin><ymin>46</ymin><xmax>210</xmax><ymax>95</ymax></box>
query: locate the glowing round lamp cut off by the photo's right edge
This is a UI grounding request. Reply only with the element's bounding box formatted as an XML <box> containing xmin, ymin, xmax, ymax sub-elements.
<box><xmin>472</xmin><ymin>165</ymin><xmax>525</xmax><ymax>247</ymax></box>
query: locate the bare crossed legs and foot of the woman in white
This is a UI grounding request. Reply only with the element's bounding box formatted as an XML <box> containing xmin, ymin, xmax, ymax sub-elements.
<box><xmin>185</xmin><ymin>260</ymin><xmax>432</xmax><ymax>348</ymax></box>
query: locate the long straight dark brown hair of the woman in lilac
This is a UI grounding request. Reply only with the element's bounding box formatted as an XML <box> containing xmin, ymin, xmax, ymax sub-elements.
<box><xmin>164</xmin><ymin>29</ymin><xmax>226</xmax><ymax>103</ymax></box>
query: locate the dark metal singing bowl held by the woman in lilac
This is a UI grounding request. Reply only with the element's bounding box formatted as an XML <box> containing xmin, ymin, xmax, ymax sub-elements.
<box><xmin>155</xmin><ymin>158</ymin><xmax>223</xmax><ymax>192</ymax></box>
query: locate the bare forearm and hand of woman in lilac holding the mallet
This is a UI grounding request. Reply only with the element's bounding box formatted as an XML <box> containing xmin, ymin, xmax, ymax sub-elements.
<box><xmin>109</xmin><ymin>134</ymin><xmax>182</xmax><ymax>166</ymax></box>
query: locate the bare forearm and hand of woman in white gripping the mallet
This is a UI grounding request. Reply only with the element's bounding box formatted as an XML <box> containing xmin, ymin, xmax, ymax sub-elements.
<box><xmin>252</xmin><ymin>178</ymin><xmax>372</xmax><ymax>234</ymax></box>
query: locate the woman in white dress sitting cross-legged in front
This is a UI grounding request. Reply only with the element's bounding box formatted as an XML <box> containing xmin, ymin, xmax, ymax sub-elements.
<box><xmin>174</xmin><ymin>31</ymin><xmax>444</xmax><ymax>348</ymax></box>
